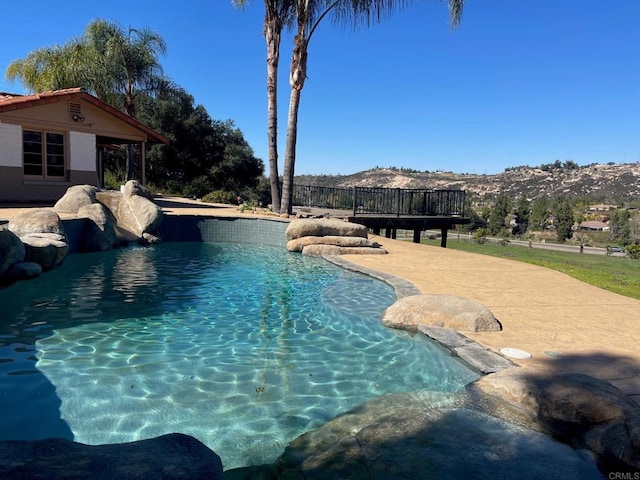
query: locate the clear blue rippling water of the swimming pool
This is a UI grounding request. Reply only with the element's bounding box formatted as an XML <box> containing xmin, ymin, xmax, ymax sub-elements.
<box><xmin>0</xmin><ymin>242</ymin><xmax>477</xmax><ymax>469</ymax></box>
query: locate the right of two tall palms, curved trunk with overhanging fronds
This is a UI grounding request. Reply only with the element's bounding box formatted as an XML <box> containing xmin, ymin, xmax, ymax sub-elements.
<box><xmin>280</xmin><ymin>0</ymin><xmax>464</xmax><ymax>214</ymax></box>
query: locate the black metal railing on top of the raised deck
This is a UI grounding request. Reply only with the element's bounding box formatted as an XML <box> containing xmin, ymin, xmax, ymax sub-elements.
<box><xmin>293</xmin><ymin>185</ymin><xmax>465</xmax><ymax>217</ymax></box>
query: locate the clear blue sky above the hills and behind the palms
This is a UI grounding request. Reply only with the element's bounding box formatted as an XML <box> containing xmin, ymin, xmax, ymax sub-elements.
<box><xmin>0</xmin><ymin>0</ymin><xmax>640</xmax><ymax>174</ymax></box>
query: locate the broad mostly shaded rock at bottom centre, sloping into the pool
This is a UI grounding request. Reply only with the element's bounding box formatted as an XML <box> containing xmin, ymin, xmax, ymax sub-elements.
<box><xmin>273</xmin><ymin>391</ymin><xmax>602</xmax><ymax>480</ymax></box>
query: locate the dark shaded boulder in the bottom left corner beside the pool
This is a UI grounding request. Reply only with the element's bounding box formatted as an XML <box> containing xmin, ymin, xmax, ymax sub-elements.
<box><xmin>0</xmin><ymin>433</ymin><xmax>223</xmax><ymax>480</ymax></box>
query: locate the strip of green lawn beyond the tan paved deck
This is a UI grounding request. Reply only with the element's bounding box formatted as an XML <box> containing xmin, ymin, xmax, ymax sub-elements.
<box><xmin>422</xmin><ymin>238</ymin><xmax>640</xmax><ymax>300</ymax></box>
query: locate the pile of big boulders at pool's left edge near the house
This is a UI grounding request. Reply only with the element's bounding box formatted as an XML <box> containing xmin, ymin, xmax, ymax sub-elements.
<box><xmin>0</xmin><ymin>180</ymin><xmax>163</xmax><ymax>286</ymax></box>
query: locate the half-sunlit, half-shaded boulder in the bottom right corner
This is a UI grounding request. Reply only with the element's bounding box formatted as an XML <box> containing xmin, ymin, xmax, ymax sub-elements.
<box><xmin>467</xmin><ymin>369</ymin><xmax>640</xmax><ymax>471</ymax></box>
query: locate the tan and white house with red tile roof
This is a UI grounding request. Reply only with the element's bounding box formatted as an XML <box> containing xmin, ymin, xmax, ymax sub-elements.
<box><xmin>0</xmin><ymin>88</ymin><xmax>169</xmax><ymax>202</ymax></box>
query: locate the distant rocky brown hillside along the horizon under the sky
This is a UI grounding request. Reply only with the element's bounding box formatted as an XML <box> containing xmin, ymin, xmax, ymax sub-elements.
<box><xmin>295</xmin><ymin>161</ymin><xmax>640</xmax><ymax>203</ymax></box>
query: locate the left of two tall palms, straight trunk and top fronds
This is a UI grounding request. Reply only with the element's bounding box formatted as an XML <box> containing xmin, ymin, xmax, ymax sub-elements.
<box><xmin>233</xmin><ymin>0</ymin><xmax>294</xmax><ymax>212</ymax></box>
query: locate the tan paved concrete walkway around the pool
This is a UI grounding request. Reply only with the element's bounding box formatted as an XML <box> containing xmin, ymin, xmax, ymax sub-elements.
<box><xmin>0</xmin><ymin>199</ymin><xmax>640</xmax><ymax>403</ymax></box>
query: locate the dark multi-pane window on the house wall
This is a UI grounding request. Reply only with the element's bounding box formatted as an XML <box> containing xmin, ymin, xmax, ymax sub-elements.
<box><xmin>22</xmin><ymin>130</ymin><xmax>65</xmax><ymax>180</ymax></box>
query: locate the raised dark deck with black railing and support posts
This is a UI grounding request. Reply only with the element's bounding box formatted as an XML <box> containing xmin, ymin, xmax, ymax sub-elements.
<box><xmin>293</xmin><ymin>185</ymin><xmax>469</xmax><ymax>247</ymax></box>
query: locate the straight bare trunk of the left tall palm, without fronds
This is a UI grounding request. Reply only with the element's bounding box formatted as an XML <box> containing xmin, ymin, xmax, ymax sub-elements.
<box><xmin>265</xmin><ymin>12</ymin><xmax>282</xmax><ymax>212</ymax></box>
